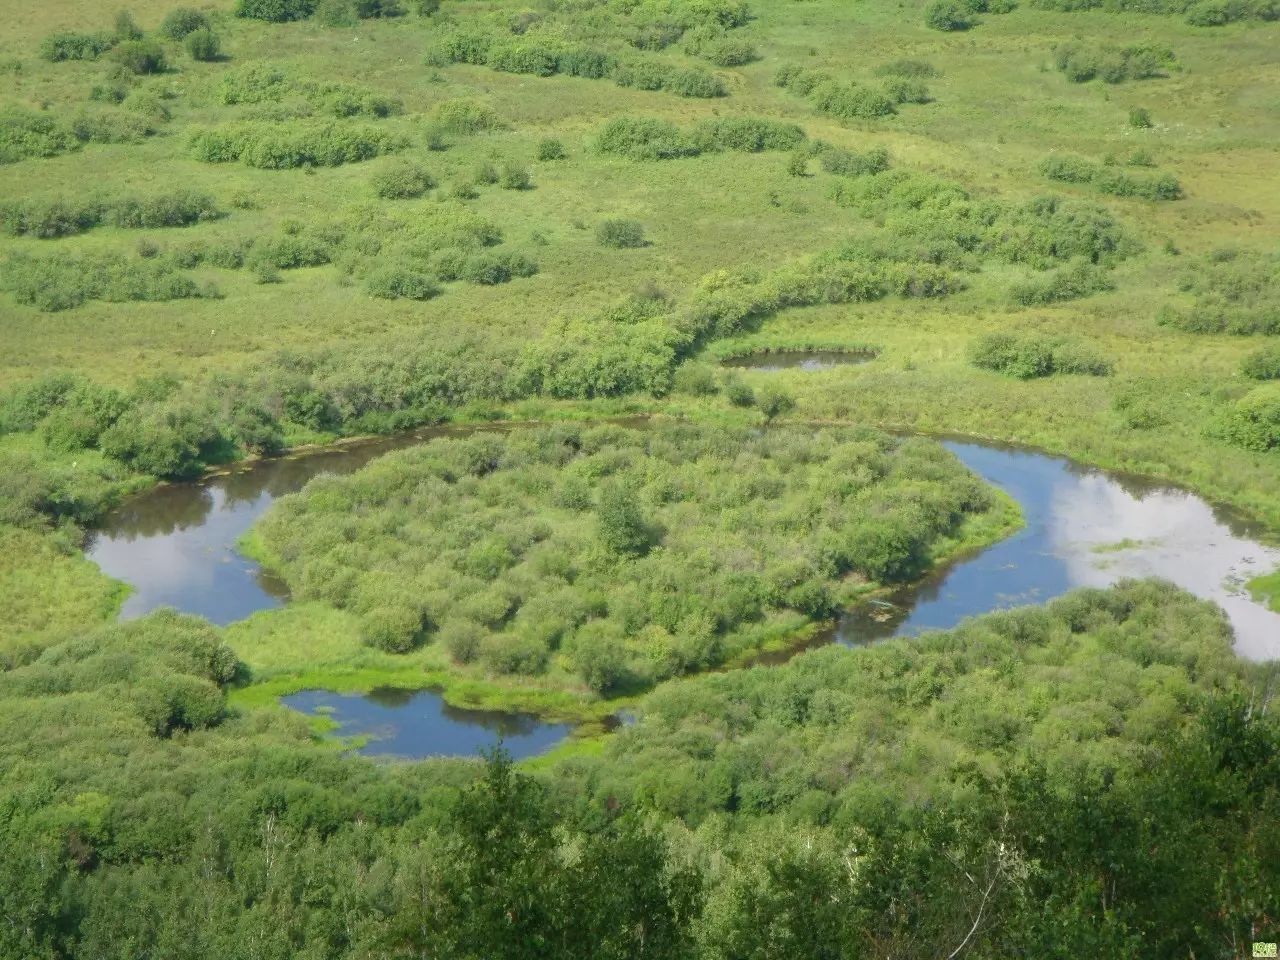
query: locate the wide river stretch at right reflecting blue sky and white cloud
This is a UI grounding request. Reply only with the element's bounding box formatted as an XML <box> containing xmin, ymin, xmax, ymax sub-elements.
<box><xmin>833</xmin><ymin>442</ymin><xmax>1280</xmax><ymax>659</ymax></box>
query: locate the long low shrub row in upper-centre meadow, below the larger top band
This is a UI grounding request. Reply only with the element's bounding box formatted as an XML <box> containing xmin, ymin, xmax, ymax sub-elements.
<box><xmin>595</xmin><ymin>116</ymin><xmax>805</xmax><ymax>160</ymax></box>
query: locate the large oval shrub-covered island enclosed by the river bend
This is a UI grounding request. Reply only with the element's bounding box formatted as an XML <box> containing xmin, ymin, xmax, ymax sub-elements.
<box><xmin>260</xmin><ymin>426</ymin><xmax>991</xmax><ymax>692</ymax></box>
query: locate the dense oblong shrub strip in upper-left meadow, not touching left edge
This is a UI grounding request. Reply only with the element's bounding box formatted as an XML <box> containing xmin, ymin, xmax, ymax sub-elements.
<box><xmin>191</xmin><ymin>120</ymin><xmax>406</xmax><ymax>170</ymax></box>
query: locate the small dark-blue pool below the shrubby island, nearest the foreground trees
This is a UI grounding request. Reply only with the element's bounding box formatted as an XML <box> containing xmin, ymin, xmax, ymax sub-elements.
<box><xmin>282</xmin><ymin>687</ymin><xmax>572</xmax><ymax>760</ymax></box>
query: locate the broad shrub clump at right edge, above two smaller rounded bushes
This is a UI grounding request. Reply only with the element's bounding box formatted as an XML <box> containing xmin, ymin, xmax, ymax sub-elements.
<box><xmin>1156</xmin><ymin>250</ymin><xmax>1280</xmax><ymax>335</ymax></box>
